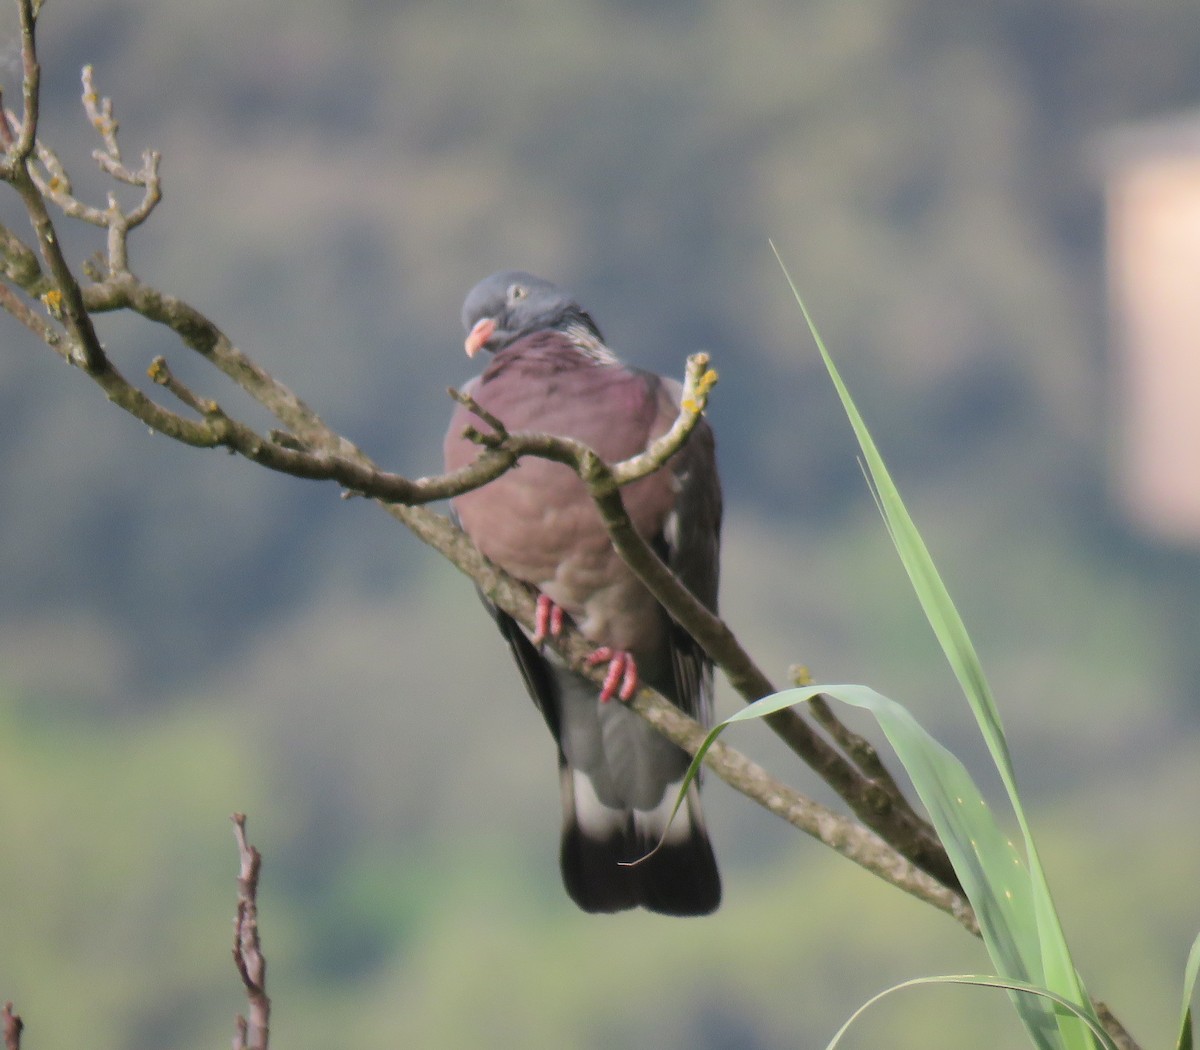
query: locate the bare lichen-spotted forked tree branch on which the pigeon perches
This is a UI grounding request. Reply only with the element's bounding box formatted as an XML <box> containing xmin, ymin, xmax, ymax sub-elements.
<box><xmin>0</xmin><ymin>26</ymin><xmax>958</xmax><ymax>912</ymax></box>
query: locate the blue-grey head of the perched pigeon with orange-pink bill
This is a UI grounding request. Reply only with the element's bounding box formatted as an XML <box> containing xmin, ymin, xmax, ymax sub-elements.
<box><xmin>462</xmin><ymin>270</ymin><xmax>600</xmax><ymax>358</ymax></box>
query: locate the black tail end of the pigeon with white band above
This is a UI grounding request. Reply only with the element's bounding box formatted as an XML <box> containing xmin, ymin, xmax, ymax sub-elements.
<box><xmin>560</xmin><ymin>764</ymin><xmax>721</xmax><ymax>916</ymax></box>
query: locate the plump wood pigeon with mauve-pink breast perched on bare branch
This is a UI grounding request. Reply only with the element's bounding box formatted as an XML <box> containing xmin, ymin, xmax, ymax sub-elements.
<box><xmin>445</xmin><ymin>271</ymin><xmax>721</xmax><ymax>916</ymax></box>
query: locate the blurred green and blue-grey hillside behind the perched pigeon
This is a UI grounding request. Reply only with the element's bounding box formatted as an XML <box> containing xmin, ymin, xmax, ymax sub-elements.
<box><xmin>0</xmin><ymin>0</ymin><xmax>1200</xmax><ymax>1050</ymax></box>
